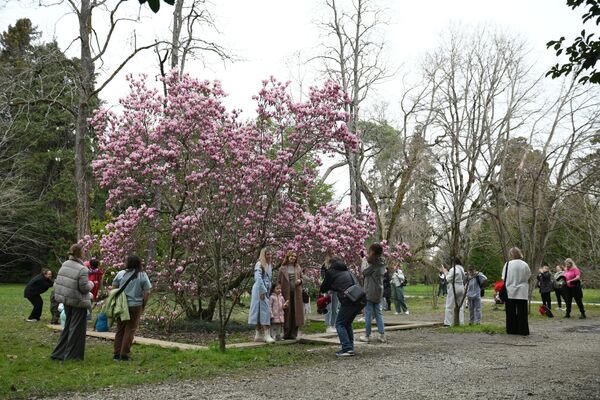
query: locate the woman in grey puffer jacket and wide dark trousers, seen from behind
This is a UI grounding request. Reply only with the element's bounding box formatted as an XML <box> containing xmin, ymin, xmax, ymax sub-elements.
<box><xmin>50</xmin><ymin>244</ymin><xmax>94</xmax><ymax>361</ymax></box>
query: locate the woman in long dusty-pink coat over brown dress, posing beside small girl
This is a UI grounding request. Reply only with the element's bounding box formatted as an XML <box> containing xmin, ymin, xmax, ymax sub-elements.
<box><xmin>279</xmin><ymin>250</ymin><xmax>304</xmax><ymax>340</ymax></box>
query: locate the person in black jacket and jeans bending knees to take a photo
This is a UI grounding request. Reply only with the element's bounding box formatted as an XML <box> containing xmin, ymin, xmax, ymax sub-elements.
<box><xmin>320</xmin><ymin>257</ymin><xmax>364</xmax><ymax>357</ymax></box>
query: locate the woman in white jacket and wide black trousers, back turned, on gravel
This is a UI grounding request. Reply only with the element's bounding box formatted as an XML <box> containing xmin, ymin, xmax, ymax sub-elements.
<box><xmin>502</xmin><ymin>247</ymin><xmax>531</xmax><ymax>336</ymax></box>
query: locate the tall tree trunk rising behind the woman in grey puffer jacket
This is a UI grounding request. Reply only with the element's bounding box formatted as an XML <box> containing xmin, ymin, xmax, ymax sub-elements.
<box><xmin>75</xmin><ymin>0</ymin><xmax>94</xmax><ymax>239</ymax></box>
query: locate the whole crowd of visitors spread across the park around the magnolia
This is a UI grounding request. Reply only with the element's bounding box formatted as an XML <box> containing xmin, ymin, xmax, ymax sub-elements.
<box><xmin>24</xmin><ymin>243</ymin><xmax>586</xmax><ymax>361</ymax></box>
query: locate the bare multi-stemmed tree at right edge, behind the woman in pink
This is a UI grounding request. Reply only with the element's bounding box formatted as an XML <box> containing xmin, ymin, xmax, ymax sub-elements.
<box><xmin>510</xmin><ymin>79</ymin><xmax>600</xmax><ymax>276</ymax></box>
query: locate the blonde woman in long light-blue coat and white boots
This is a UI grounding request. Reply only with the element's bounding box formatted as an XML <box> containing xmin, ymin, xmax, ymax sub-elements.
<box><xmin>248</xmin><ymin>247</ymin><xmax>275</xmax><ymax>343</ymax></box>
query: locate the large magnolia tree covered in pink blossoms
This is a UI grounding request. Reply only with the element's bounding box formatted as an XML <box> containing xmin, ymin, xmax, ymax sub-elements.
<box><xmin>92</xmin><ymin>72</ymin><xmax>373</xmax><ymax>348</ymax></box>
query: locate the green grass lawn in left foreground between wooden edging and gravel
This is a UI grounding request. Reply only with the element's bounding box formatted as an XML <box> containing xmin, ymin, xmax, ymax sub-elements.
<box><xmin>0</xmin><ymin>285</ymin><xmax>331</xmax><ymax>398</ymax></box>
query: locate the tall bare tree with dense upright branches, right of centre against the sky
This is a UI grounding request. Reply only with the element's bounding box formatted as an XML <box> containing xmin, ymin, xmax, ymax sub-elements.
<box><xmin>424</xmin><ymin>31</ymin><xmax>533</xmax><ymax>324</ymax></box>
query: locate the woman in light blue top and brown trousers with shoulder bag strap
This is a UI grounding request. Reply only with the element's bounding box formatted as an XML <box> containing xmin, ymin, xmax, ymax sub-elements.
<box><xmin>112</xmin><ymin>256</ymin><xmax>152</xmax><ymax>361</ymax></box>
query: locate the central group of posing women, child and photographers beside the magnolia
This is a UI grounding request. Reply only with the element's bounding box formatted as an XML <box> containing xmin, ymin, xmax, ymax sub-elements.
<box><xmin>248</xmin><ymin>243</ymin><xmax>409</xmax><ymax>357</ymax></box>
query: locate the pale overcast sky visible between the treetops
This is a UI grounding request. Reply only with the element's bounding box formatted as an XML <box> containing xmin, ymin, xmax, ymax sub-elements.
<box><xmin>0</xmin><ymin>0</ymin><xmax>581</xmax><ymax>203</ymax></box>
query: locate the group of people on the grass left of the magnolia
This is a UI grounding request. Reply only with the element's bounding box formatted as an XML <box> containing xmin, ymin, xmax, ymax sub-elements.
<box><xmin>24</xmin><ymin>244</ymin><xmax>152</xmax><ymax>361</ymax></box>
